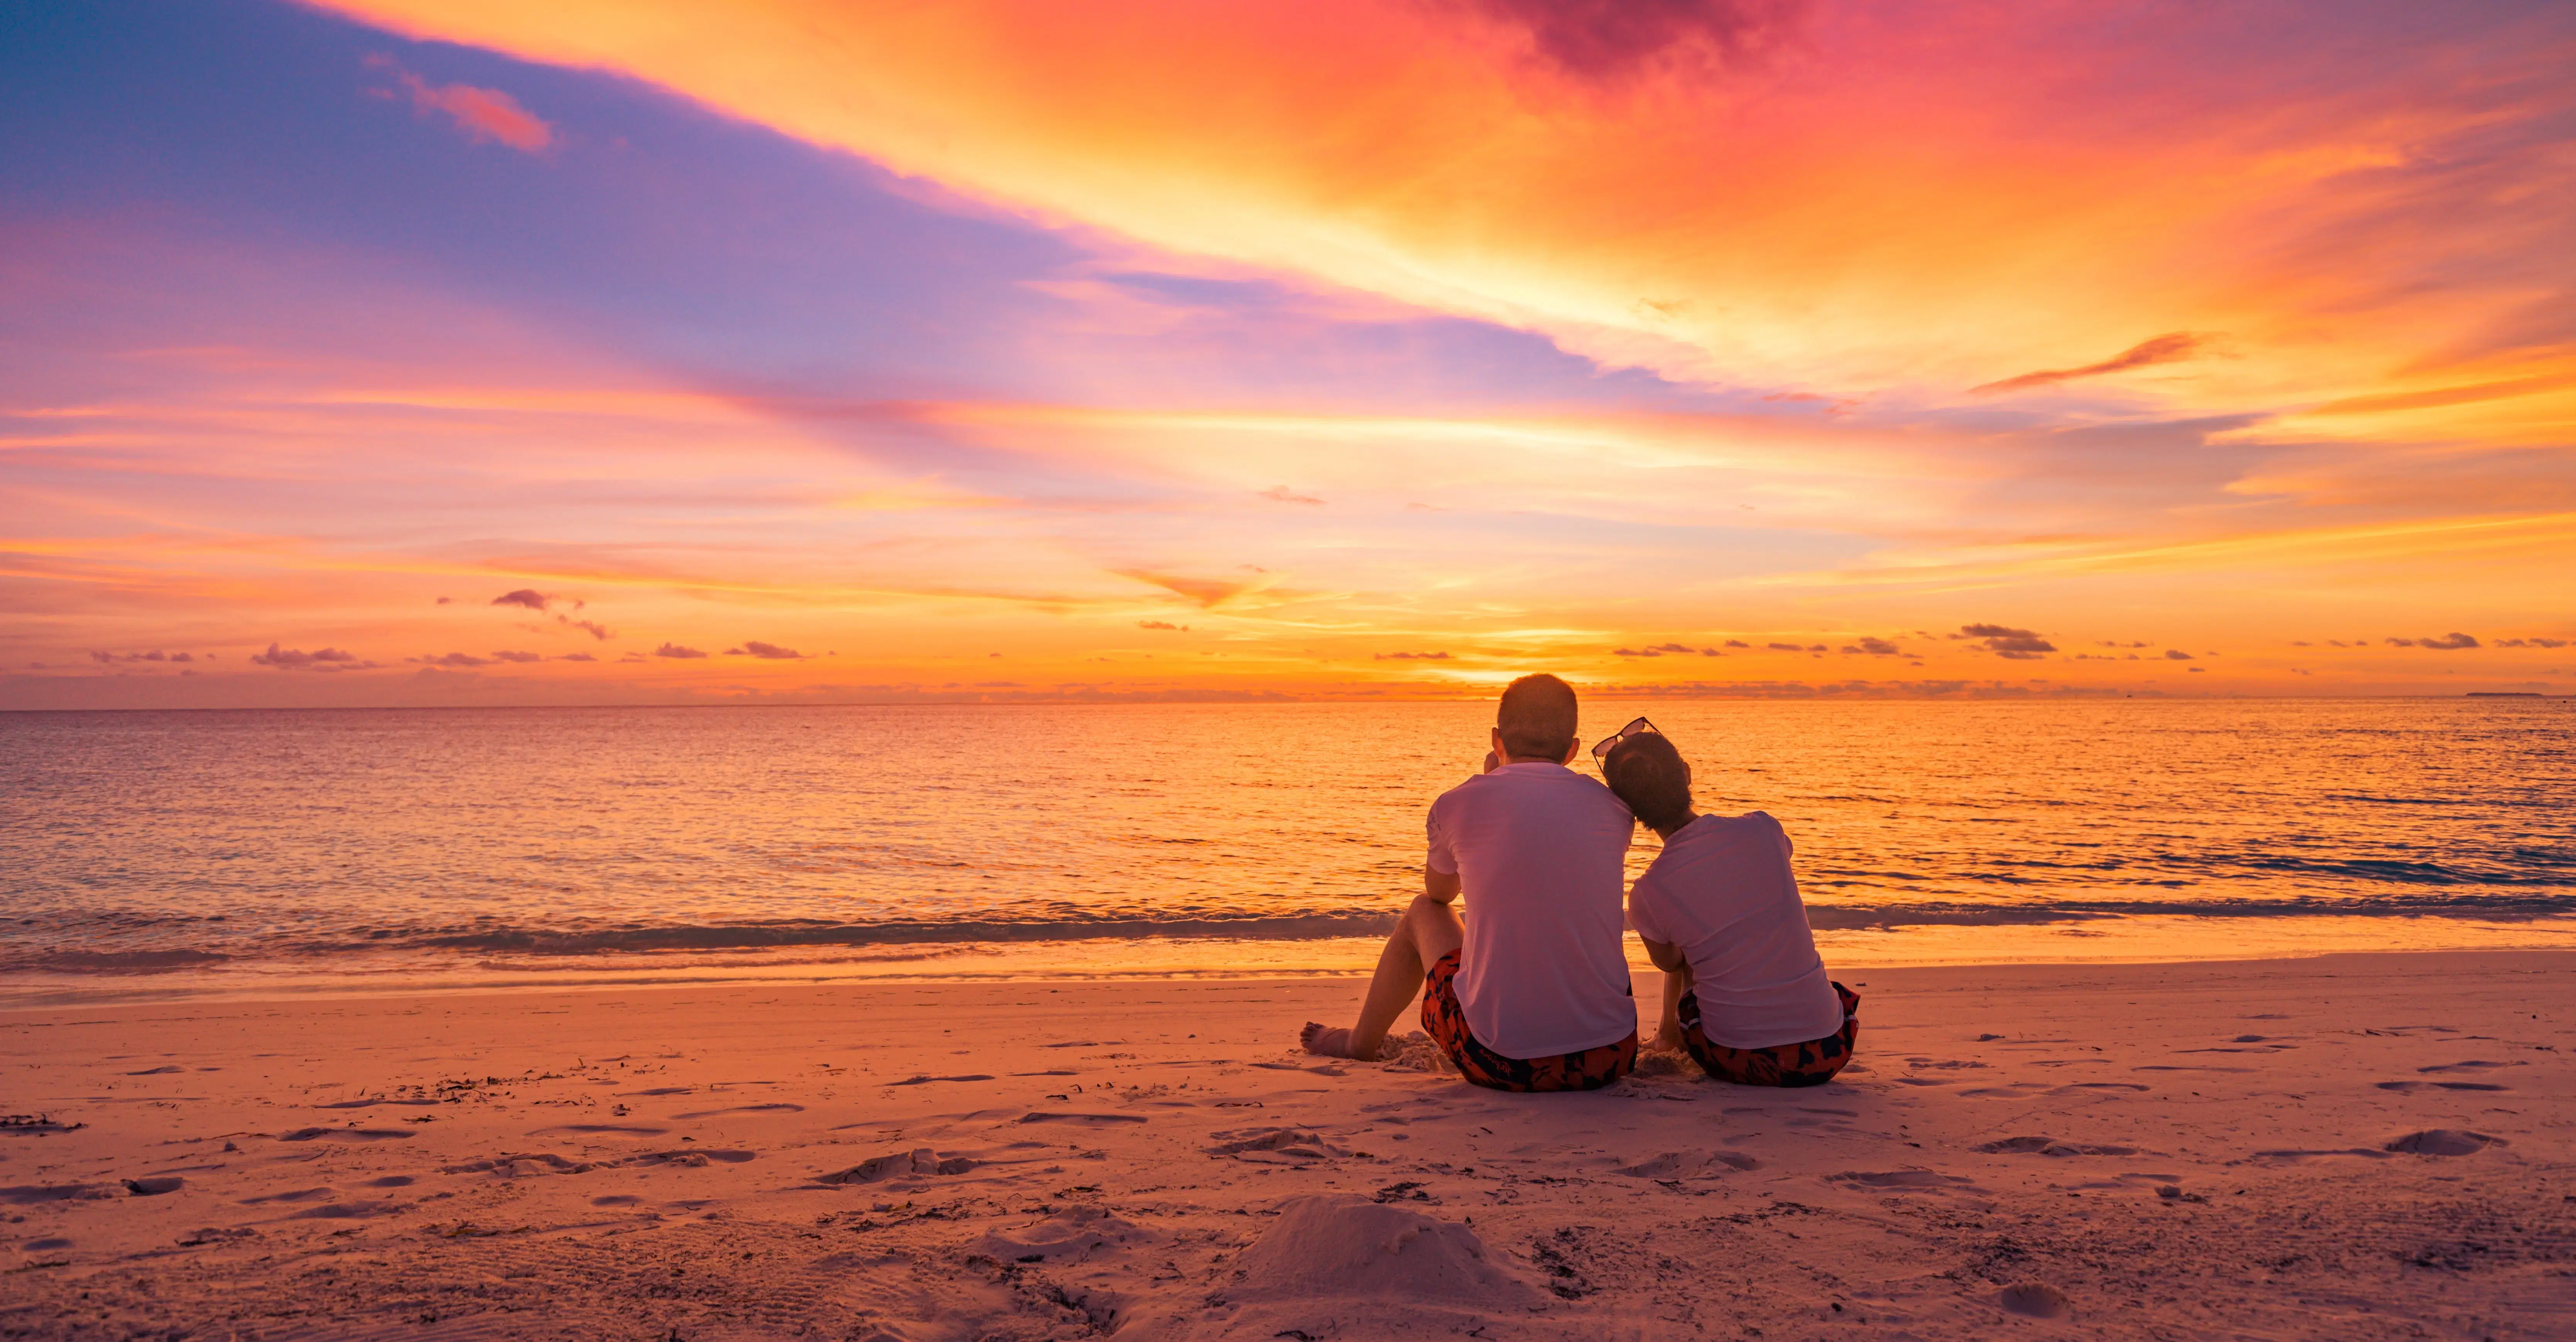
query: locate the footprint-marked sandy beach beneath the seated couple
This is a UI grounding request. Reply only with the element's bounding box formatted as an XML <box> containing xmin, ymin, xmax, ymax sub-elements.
<box><xmin>0</xmin><ymin>953</ymin><xmax>2576</xmax><ymax>1342</ymax></box>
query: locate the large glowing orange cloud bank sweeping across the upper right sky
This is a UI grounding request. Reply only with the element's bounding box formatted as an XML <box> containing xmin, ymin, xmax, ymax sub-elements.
<box><xmin>330</xmin><ymin>0</ymin><xmax>2576</xmax><ymax>425</ymax></box>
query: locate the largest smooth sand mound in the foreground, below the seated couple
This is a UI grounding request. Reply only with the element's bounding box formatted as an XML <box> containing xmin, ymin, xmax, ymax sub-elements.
<box><xmin>1229</xmin><ymin>1195</ymin><xmax>1540</xmax><ymax>1308</ymax></box>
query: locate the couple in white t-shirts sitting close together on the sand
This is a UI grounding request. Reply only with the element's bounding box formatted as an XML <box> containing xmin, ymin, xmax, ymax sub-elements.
<box><xmin>1303</xmin><ymin>675</ymin><xmax>1860</xmax><ymax>1090</ymax></box>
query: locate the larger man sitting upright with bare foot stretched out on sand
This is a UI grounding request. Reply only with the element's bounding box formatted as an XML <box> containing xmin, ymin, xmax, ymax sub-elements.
<box><xmin>1303</xmin><ymin>675</ymin><xmax>1636</xmax><ymax>1090</ymax></box>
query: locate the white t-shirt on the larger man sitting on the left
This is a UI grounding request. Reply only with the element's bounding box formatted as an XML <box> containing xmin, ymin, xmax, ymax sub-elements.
<box><xmin>1427</xmin><ymin>765</ymin><xmax>1636</xmax><ymax>1058</ymax></box>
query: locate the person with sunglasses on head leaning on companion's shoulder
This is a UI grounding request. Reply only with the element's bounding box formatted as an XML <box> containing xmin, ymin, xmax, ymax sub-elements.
<box><xmin>1594</xmin><ymin>719</ymin><xmax>1860</xmax><ymax>1087</ymax></box>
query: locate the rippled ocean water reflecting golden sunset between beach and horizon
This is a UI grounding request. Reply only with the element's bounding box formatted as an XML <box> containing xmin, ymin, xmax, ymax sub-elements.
<box><xmin>0</xmin><ymin>701</ymin><xmax>2576</xmax><ymax>1004</ymax></box>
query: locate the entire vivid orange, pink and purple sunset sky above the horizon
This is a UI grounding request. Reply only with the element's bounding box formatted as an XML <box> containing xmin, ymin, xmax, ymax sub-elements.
<box><xmin>0</xmin><ymin>0</ymin><xmax>2576</xmax><ymax>708</ymax></box>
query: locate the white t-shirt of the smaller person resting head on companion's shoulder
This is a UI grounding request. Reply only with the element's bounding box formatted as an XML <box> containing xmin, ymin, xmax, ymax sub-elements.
<box><xmin>1628</xmin><ymin>811</ymin><xmax>1842</xmax><ymax>1048</ymax></box>
